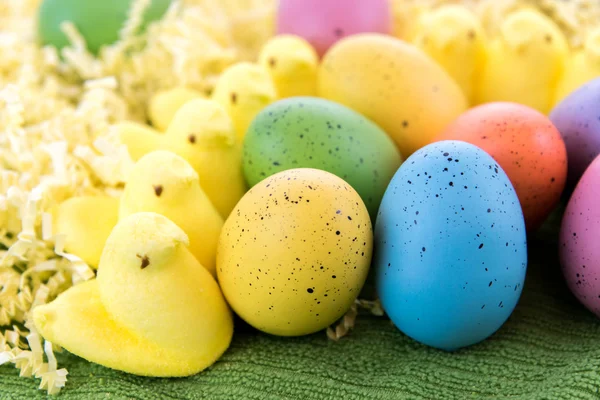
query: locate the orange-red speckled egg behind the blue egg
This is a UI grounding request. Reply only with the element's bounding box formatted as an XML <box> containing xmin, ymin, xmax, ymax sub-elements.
<box><xmin>436</xmin><ymin>102</ymin><xmax>567</xmax><ymax>231</ymax></box>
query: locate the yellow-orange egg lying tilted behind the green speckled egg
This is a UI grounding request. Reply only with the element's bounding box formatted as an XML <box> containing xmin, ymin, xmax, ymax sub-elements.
<box><xmin>318</xmin><ymin>33</ymin><xmax>467</xmax><ymax>157</ymax></box>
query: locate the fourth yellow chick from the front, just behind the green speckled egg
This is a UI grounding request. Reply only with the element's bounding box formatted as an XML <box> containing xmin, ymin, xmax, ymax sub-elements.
<box><xmin>212</xmin><ymin>62</ymin><xmax>277</xmax><ymax>143</ymax></box>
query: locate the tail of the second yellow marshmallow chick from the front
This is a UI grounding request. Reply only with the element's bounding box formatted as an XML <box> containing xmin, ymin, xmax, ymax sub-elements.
<box><xmin>53</xmin><ymin>196</ymin><xmax>119</xmax><ymax>268</ymax></box>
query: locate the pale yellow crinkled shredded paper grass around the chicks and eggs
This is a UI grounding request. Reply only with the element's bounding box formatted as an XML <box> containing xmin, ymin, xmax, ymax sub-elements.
<box><xmin>0</xmin><ymin>0</ymin><xmax>600</xmax><ymax>398</ymax></box>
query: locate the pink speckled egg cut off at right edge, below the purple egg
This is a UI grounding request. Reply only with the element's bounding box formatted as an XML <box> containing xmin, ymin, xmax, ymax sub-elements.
<box><xmin>560</xmin><ymin>156</ymin><xmax>600</xmax><ymax>317</ymax></box>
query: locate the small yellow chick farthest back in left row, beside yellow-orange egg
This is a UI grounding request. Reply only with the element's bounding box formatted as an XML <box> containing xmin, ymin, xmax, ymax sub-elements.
<box><xmin>258</xmin><ymin>35</ymin><xmax>319</xmax><ymax>99</ymax></box>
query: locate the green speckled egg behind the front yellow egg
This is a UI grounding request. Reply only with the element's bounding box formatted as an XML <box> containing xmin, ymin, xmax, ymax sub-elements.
<box><xmin>243</xmin><ymin>97</ymin><xmax>402</xmax><ymax>220</ymax></box>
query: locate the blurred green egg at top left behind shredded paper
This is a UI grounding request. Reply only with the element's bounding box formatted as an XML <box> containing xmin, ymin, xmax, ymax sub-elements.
<box><xmin>38</xmin><ymin>0</ymin><xmax>171</xmax><ymax>54</ymax></box>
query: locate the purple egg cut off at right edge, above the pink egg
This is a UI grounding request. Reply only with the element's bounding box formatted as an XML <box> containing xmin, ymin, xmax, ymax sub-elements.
<box><xmin>550</xmin><ymin>78</ymin><xmax>600</xmax><ymax>187</ymax></box>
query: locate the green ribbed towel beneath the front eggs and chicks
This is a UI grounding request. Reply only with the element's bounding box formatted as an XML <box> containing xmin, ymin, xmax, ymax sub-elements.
<box><xmin>0</xmin><ymin>206</ymin><xmax>600</xmax><ymax>400</ymax></box>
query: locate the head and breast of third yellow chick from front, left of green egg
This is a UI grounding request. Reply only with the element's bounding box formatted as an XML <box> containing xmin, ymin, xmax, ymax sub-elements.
<box><xmin>165</xmin><ymin>99</ymin><xmax>247</xmax><ymax>218</ymax></box>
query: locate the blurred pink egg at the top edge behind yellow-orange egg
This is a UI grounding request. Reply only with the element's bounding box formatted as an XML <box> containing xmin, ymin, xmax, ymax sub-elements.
<box><xmin>277</xmin><ymin>0</ymin><xmax>392</xmax><ymax>56</ymax></box>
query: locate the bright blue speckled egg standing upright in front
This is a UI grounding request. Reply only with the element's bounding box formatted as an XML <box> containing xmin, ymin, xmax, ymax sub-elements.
<box><xmin>374</xmin><ymin>141</ymin><xmax>527</xmax><ymax>350</ymax></box>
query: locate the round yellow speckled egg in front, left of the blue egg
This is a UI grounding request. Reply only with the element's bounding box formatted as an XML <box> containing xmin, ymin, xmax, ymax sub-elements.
<box><xmin>217</xmin><ymin>168</ymin><xmax>373</xmax><ymax>336</ymax></box>
